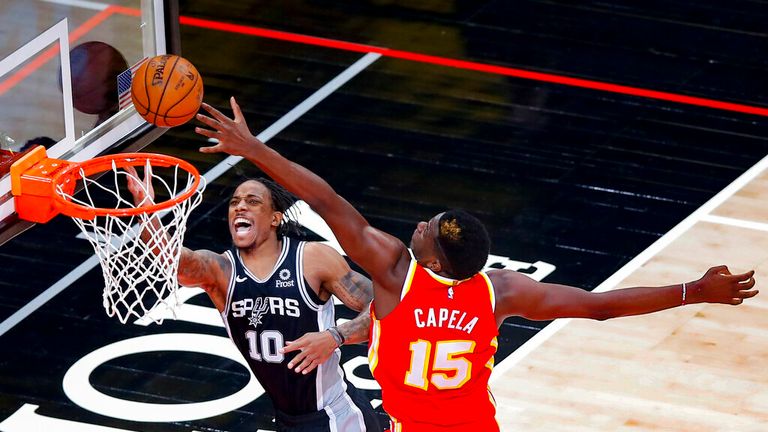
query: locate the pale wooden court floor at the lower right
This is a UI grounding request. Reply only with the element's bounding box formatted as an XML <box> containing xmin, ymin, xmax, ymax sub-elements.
<box><xmin>492</xmin><ymin>165</ymin><xmax>768</xmax><ymax>432</ymax></box>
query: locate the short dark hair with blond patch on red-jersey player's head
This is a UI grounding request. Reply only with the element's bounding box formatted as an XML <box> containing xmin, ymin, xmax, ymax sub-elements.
<box><xmin>437</xmin><ymin>209</ymin><xmax>491</xmax><ymax>279</ymax></box>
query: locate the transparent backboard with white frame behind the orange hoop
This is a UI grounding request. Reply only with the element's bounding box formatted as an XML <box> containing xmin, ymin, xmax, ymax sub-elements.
<box><xmin>0</xmin><ymin>0</ymin><xmax>179</xmax><ymax>244</ymax></box>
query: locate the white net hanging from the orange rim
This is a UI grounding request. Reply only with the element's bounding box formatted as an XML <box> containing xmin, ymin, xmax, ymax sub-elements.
<box><xmin>56</xmin><ymin>161</ymin><xmax>205</xmax><ymax>324</ymax></box>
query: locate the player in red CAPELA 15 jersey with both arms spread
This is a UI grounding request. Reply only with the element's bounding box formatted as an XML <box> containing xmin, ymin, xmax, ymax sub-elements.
<box><xmin>196</xmin><ymin>98</ymin><xmax>758</xmax><ymax>432</ymax></box>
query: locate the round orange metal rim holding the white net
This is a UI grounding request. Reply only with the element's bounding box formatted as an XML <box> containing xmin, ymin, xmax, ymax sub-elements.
<box><xmin>51</xmin><ymin>153</ymin><xmax>200</xmax><ymax>220</ymax></box>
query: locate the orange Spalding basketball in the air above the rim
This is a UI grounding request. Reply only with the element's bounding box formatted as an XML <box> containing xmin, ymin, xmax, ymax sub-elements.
<box><xmin>131</xmin><ymin>54</ymin><xmax>203</xmax><ymax>127</ymax></box>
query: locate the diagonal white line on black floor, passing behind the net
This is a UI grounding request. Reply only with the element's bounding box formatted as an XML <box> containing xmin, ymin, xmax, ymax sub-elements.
<box><xmin>0</xmin><ymin>53</ymin><xmax>381</xmax><ymax>336</ymax></box>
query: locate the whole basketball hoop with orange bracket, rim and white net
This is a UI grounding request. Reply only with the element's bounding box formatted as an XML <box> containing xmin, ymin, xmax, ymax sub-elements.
<box><xmin>11</xmin><ymin>147</ymin><xmax>205</xmax><ymax>324</ymax></box>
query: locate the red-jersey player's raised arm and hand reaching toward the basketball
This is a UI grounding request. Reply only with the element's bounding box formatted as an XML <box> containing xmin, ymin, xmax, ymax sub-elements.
<box><xmin>195</xmin><ymin>98</ymin><xmax>408</xmax><ymax>289</ymax></box>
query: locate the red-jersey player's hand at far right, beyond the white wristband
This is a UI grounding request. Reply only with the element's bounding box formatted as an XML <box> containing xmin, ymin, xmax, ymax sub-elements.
<box><xmin>688</xmin><ymin>266</ymin><xmax>759</xmax><ymax>305</ymax></box>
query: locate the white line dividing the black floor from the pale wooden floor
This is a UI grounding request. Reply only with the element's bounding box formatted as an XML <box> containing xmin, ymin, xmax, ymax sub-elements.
<box><xmin>490</xmin><ymin>151</ymin><xmax>768</xmax><ymax>383</ymax></box>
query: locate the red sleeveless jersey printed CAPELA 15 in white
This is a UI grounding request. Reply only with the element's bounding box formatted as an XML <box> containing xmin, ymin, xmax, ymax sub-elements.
<box><xmin>368</xmin><ymin>255</ymin><xmax>499</xmax><ymax>432</ymax></box>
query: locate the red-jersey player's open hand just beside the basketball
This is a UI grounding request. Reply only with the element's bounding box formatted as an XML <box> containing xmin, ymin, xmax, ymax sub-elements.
<box><xmin>195</xmin><ymin>96</ymin><xmax>263</xmax><ymax>156</ymax></box>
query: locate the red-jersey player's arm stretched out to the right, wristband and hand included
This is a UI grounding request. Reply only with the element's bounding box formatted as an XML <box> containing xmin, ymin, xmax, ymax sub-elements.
<box><xmin>488</xmin><ymin>266</ymin><xmax>758</xmax><ymax>320</ymax></box>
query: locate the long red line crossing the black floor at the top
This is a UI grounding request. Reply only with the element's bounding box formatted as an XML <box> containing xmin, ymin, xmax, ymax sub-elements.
<box><xmin>172</xmin><ymin>16</ymin><xmax>768</xmax><ymax>116</ymax></box>
